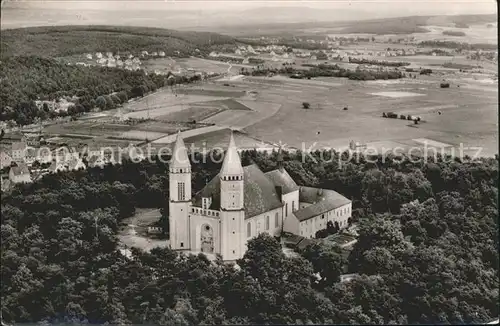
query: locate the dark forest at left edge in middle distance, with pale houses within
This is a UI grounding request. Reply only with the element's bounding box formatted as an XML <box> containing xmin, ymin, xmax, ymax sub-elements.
<box><xmin>0</xmin><ymin>56</ymin><xmax>203</xmax><ymax>125</ymax></box>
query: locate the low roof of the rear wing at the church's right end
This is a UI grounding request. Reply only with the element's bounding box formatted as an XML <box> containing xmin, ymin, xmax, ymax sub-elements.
<box><xmin>293</xmin><ymin>187</ymin><xmax>351</xmax><ymax>221</ymax></box>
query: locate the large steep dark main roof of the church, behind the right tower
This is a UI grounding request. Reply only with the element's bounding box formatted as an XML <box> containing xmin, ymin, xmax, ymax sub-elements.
<box><xmin>193</xmin><ymin>165</ymin><xmax>282</xmax><ymax>218</ymax></box>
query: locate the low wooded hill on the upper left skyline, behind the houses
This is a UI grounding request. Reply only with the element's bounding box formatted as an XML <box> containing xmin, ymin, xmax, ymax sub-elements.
<box><xmin>1</xmin><ymin>26</ymin><xmax>235</xmax><ymax>58</ymax></box>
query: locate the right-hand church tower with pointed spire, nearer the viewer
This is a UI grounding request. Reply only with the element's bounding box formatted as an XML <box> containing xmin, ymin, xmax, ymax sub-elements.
<box><xmin>220</xmin><ymin>132</ymin><xmax>246</xmax><ymax>260</ymax></box>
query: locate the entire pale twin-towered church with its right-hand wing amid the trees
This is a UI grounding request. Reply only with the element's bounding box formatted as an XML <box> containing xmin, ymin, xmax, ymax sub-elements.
<box><xmin>169</xmin><ymin>134</ymin><xmax>351</xmax><ymax>261</ymax></box>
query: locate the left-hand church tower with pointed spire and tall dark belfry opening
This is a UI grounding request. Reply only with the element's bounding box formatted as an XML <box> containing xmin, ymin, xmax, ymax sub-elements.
<box><xmin>168</xmin><ymin>132</ymin><xmax>191</xmax><ymax>250</ymax></box>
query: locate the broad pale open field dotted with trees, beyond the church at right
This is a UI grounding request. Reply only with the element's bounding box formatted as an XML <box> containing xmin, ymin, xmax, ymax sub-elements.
<box><xmin>237</xmin><ymin>70</ymin><xmax>498</xmax><ymax>155</ymax></box>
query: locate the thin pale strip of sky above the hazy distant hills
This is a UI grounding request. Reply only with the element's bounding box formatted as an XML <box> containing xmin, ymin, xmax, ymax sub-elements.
<box><xmin>4</xmin><ymin>0</ymin><xmax>497</xmax><ymax>16</ymax></box>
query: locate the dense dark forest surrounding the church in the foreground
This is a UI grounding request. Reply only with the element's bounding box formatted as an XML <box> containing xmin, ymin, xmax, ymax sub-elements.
<box><xmin>1</xmin><ymin>151</ymin><xmax>499</xmax><ymax>325</ymax></box>
